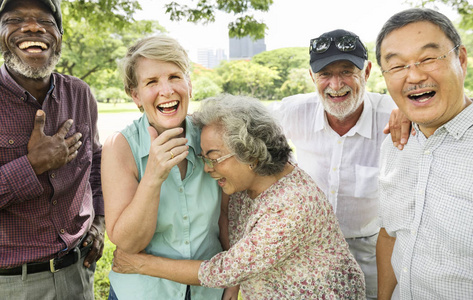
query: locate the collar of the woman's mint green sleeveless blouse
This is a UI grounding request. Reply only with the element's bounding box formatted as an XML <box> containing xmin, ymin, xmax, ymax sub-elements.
<box><xmin>138</xmin><ymin>114</ymin><xmax>198</xmax><ymax>163</ymax></box>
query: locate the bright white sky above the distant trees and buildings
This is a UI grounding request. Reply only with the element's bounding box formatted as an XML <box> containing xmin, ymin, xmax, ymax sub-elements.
<box><xmin>135</xmin><ymin>0</ymin><xmax>458</xmax><ymax>61</ymax></box>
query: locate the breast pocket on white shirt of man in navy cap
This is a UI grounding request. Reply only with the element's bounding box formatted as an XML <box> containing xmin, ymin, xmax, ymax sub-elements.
<box><xmin>355</xmin><ymin>165</ymin><xmax>379</xmax><ymax>198</ymax></box>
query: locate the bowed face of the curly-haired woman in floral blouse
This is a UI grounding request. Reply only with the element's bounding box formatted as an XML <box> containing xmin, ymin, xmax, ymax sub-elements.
<box><xmin>201</xmin><ymin>124</ymin><xmax>256</xmax><ymax>195</ymax></box>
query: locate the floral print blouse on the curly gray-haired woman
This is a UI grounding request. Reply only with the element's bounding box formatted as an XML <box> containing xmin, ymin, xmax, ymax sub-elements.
<box><xmin>199</xmin><ymin>166</ymin><xmax>365</xmax><ymax>300</ymax></box>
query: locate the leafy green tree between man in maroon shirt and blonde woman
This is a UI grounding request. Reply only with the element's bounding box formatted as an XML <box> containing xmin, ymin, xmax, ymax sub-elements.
<box><xmin>56</xmin><ymin>1</ymin><xmax>164</xmax><ymax>89</ymax></box>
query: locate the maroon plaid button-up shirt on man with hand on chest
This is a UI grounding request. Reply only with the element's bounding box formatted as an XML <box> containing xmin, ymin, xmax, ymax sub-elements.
<box><xmin>0</xmin><ymin>65</ymin><xmax>104</xmax><ymax>268</ymax></box>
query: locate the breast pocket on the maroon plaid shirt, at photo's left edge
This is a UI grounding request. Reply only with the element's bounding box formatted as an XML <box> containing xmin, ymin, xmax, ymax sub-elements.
<box><xmin>0</xmin><ymin>134</ymin><xmax>30</xmax><ymax>166</ymax></box>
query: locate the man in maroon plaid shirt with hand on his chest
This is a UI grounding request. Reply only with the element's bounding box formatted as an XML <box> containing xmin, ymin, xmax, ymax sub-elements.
<box><xmin>0</xmin><ymin>0</ymin><xmax>105</xmax><ymax>299</ymax></box>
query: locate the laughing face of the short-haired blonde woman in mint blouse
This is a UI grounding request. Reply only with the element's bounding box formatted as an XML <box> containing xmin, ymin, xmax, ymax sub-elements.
<box><xmin>131</xmin><ymin>57</ymin><xmax>192</xmax><ymax>134</ymax></box>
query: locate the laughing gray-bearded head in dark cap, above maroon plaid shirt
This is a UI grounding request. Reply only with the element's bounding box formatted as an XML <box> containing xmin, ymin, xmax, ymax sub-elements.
<box><xmin>0</xmin><ymin>0</ymin><xmax>62</xmax><ymax>79</ymax></box>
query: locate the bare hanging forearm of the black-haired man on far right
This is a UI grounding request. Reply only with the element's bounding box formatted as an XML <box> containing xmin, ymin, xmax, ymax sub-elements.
<box><xmin>376</xmin><ymin>228</ymin><xmax>397</xmax><ymax>300</ymax></box>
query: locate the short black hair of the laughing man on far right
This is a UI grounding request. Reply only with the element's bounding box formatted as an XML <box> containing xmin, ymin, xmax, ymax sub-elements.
<box><xmin>376</xmin><ymin>8</ymin><xmax>462</xmax><ymax>66</ymax></box>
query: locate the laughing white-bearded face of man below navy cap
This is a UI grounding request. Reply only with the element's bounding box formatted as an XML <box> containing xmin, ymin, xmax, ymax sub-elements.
<box><xmin>311</xmin><ymin>61</ymin><xmax>371</xmax><ymax>121</ymax></box>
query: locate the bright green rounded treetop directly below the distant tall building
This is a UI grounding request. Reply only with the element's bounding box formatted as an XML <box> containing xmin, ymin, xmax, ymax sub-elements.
<box><xmin>216</xmin><ymin>60</ymin><xmax>279</xmax><ymax>99</ymax></box>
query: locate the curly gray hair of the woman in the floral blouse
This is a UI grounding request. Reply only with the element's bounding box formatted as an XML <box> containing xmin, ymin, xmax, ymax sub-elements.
<box><xmin>193</xmin><ymin>94</ymin><xmax>292</xmax><ymax>176</ymax></box>
